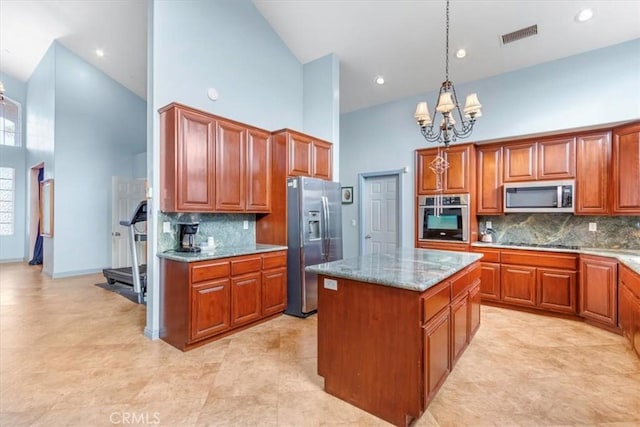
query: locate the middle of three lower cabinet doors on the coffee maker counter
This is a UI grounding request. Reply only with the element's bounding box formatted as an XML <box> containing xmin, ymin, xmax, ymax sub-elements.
<box><xmin>231</xmin><ymin>273</ymin><xmax>262</xmax><ymax>326</ymax></box>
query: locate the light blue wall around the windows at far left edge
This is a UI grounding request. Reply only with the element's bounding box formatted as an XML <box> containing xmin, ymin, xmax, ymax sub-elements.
<box><xmin>0</xmin><ymin>73</ymin><xmax>27</xmax><ymax>262</ymax></box>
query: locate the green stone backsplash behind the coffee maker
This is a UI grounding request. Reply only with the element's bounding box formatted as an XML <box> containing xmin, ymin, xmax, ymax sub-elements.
<box><xmin>158</xmin><ymin>212</ymin><xmax>256</xmax><ymax>252</ymax></box>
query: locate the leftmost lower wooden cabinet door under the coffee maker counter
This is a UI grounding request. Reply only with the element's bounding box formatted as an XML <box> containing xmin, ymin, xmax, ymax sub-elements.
<box><xmin>190</xmin><ymin>279</ymin><xmax>231</xmax><ymax>341</ymax></box>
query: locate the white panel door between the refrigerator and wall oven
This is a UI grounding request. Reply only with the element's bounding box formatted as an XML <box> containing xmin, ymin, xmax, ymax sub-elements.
<box><xmin>363</xmin><ymin>175</ymin><xmax>398</xmax><ymax>254</ymax></box>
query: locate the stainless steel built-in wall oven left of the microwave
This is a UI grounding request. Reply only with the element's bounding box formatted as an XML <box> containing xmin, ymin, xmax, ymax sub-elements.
<box><xmin>417</xmin><ymin>194</ymin><xmax>469</xmax><ymax>242</ymax></box>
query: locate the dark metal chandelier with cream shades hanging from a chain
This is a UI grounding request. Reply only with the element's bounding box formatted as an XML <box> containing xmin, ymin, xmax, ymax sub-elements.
<box><xmin>415</xmin><ymin>0</ymin><xmax>482</xmax><ymax>148</ymax></box>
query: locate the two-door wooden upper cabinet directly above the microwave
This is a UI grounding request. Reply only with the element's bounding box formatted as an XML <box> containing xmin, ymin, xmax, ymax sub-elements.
<box><xmin>503</xmin><ymin>137</ymin><xmax>576</xmax><ymax>182</ymax></box>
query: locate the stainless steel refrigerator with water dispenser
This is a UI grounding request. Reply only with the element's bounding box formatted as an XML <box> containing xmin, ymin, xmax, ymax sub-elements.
<box><xmin>285</xmin><ymin>177</ymin><xmax>342</xmax><ymax>317</ymax></box>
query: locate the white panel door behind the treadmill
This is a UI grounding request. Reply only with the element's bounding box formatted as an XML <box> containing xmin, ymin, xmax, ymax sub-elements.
<box><xmin>111</xmin><ymin>176</ymin><xmax>147</xmax><ymax>268</ymax></box>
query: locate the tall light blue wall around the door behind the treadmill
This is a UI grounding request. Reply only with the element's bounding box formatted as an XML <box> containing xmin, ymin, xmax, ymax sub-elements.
<box><xmin>53</xmin><ymin>44</ymin><xmax>146</xmax><ymax>276</ymax></box>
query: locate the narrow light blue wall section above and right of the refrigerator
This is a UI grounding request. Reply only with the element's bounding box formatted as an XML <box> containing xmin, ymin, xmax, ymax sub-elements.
<box><xmin>302</xmin><ymin>54</ymin><xmax>340</xmax><ymax>181</ymax></box>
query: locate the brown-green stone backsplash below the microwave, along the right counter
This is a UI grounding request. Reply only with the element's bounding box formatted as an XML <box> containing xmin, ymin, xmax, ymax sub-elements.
<box><xmin>478</xmin><ymin>213</ymin><xmax>640</xmax><ymax>249</ymax></box>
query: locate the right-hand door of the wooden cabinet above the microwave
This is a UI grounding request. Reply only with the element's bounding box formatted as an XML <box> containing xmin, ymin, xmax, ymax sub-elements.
<box><xmin>538</xmin><ymin>137</ymin><xmax>576</xmax><ymax>179</ymax></box>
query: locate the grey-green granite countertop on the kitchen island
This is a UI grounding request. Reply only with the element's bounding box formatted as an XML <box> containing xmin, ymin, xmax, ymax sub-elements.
<box><xmin>306</xmin><ymin>248</ymin><xmax>482</xmax><ymax>292</ymax></box>
